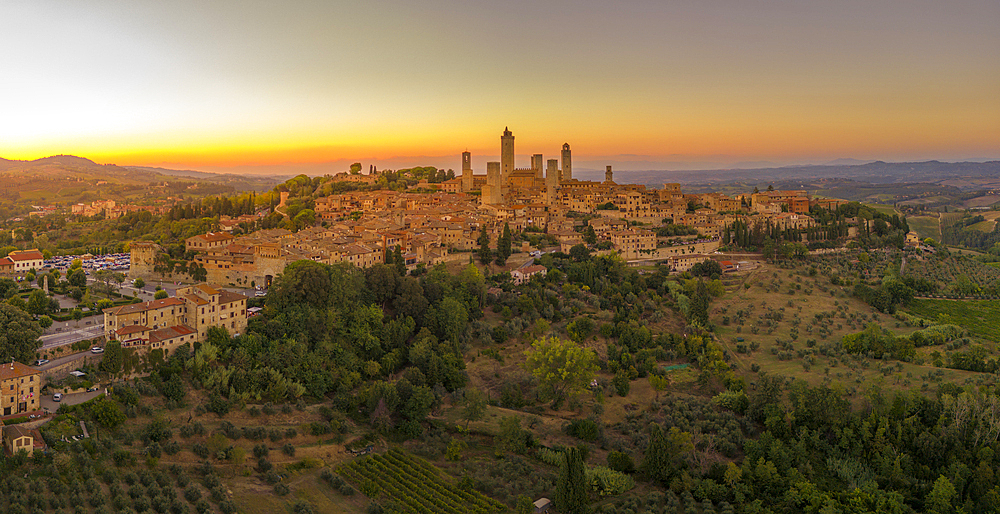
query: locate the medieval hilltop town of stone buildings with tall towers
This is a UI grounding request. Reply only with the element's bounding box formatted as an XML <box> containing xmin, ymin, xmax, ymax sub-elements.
<box><xmin>130</xmin><ymin>130</ymin><xmax>857</xmax><ymax>287</ymax></box>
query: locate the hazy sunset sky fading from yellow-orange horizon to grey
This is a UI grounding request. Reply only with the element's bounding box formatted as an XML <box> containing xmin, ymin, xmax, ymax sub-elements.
<box><xmin>0</xmin><ymin>0</ymin><xmax>1000</xmax><ymax>169</ymax></box>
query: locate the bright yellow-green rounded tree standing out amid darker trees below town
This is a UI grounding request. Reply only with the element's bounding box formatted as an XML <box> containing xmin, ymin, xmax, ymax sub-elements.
<box><xmin>525</xmin><ymin>336</ymin><xmax>597</xmax><ymax>400</ymax></box>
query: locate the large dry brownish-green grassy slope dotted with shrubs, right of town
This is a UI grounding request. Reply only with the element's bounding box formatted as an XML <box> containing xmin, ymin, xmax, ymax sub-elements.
<box><xmin>712</xmin><ymin>265</ymin><xmax>988</xmax><ymax>401</ymax></box>
